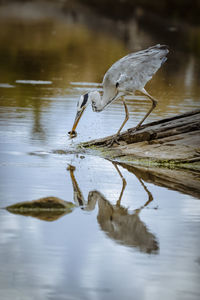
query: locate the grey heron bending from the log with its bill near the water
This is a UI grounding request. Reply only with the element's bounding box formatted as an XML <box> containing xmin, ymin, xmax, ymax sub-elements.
<box><xmin>68</xmin><ymin>44</ymin><xmax>169</xmax><ymax>145</ymax></box>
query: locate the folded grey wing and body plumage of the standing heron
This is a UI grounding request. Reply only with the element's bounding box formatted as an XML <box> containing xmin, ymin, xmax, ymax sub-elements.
<box><xmin>103</xmin><ymin>45</ymin><xmax>169</xmax><ymax>91</ymax></box>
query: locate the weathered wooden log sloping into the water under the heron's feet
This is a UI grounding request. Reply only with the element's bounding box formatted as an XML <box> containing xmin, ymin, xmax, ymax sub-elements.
<box><xmin>82</xmin><ymin>110</ymin><xmax>200</xmax><ymax>169</ymax></box>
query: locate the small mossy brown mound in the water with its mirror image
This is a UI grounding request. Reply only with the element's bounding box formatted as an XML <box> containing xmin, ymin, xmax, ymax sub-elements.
<box><xmin>6</xmin><ymin>197</ymin><xmax>75</xmax><ymax>221</ymax></box>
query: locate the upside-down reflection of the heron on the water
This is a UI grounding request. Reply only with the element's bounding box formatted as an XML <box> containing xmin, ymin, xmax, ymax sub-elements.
<box><xmin>68</xmin><ymin>163</ymin><xmax>159</xmax><ymax>253</ymax></box>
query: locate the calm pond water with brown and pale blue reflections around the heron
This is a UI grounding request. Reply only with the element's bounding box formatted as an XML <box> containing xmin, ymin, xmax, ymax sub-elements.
<box><xmin>0</xmin><ymin>5</ymin><xmax>200</xmax><ymax>300</ymax></box>
